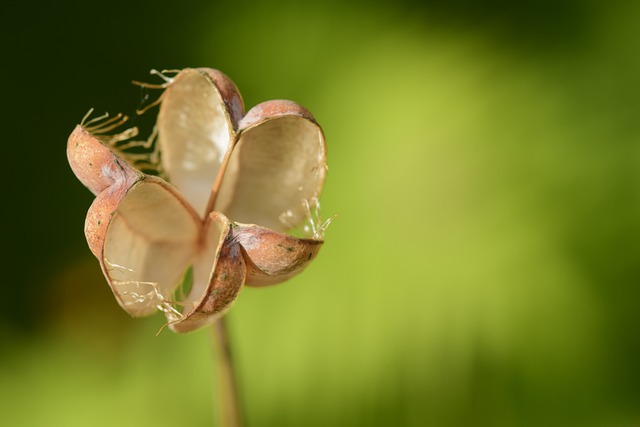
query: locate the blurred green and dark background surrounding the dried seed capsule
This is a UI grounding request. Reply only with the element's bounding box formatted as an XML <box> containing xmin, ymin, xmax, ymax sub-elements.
<box><xmin>0</xmin><ymin>0</ymin><xmax>640</xmax><ymax>427</ymax></box>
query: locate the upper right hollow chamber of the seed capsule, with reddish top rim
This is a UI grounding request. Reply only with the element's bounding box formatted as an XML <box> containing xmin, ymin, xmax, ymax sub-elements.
<box><xmin>215</xmin><ymin>100</ymin><xmax>326</xmax><ymax>231</ymax></box>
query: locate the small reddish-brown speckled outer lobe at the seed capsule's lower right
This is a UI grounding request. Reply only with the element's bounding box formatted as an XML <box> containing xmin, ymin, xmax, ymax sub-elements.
<box><xmin>233</xmin><ymin>224</ymin><xmax>324</xmax><ymax>286</ymax></box>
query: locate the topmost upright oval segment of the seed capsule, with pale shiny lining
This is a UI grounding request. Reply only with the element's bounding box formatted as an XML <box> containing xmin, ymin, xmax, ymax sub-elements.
<box><xmin>157</xmin><ymin>68</ymin><xmax>244</xmax><ymax>217</ymax></box>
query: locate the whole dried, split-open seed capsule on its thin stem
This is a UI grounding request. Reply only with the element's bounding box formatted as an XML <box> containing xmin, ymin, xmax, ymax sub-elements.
<box><xmin>67</xmin><ymin>68</ymin><xmax>329</xmax><ymax>425</ymax></box>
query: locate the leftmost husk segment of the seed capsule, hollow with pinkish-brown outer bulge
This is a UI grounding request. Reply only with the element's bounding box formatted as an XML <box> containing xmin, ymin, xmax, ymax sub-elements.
<box><xmin>67</xmin><ymin>126</ymin><xmax>201</xmax><ymax>317</ymax></box>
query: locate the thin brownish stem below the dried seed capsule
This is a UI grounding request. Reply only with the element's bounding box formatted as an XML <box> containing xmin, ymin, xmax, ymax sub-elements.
<box><xmin>212</xmin><ymin>317</ymin><xmax>242</xmax><ymax>427</ymax></box>
